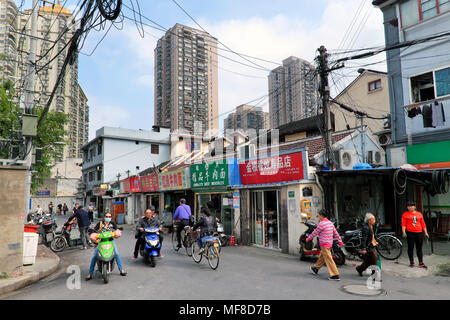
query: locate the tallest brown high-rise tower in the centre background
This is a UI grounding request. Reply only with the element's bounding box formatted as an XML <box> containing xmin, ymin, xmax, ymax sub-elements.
<box><xmin>154</xmin><ymin>24</ymin><xmax>219</xmax><ymax>134</ymax></box>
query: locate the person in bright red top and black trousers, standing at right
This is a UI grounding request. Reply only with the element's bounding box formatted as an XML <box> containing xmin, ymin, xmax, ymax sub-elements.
<box><xmin>402</xmin><ymin>201</ymin><xmax>430</xmax><ymax>269</ymax></box>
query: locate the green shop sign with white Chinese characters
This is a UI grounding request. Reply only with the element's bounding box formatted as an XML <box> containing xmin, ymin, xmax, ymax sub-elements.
<box><xmin>191</xmin><ymin>159</ymin><xmax>228</xmax><ymax>188</ymax></box>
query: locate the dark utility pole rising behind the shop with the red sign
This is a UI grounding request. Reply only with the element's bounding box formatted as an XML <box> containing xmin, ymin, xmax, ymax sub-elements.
<box><xmin>318</xmin><ymin>46</ymin><xmax>334</xmax><ymax>170</ymax></box>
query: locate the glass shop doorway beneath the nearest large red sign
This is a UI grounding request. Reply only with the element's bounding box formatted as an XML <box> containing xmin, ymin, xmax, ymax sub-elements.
<box><xmin>250</xmin><ymin>190</ymin><xmax>280</xmax><ymax>249</ymax></box>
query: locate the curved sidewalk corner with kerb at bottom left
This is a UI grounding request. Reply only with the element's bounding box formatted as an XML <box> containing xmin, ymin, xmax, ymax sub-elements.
<box><xmin>0</xmin><ymin>245</ymin><xmax>60</xmax><ymax>297</ymax></box>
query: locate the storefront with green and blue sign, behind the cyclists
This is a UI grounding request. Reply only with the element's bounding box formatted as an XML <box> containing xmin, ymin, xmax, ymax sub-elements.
<box><xmin>190</xmin><ymin>159</ymin><xmax>240</xmax><ymax>235</ymax></box>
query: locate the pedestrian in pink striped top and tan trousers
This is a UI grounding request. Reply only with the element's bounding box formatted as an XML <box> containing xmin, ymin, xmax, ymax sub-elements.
<box><xmin>306</xmin><ymin>210</ymin><xmax>344</xmax><ymax>281</ymax></box>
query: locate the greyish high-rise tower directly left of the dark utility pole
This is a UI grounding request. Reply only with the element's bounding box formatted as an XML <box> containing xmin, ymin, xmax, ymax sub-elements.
<box><xmin>268</xmin><ymin>57</ymin><xmax>317</xmax><ymax>128</ymax></box>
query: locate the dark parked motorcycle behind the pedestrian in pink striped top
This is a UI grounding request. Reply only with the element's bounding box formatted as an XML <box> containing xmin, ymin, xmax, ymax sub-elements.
<box><xmin>299</xmin><ymin>219</ymin><xmax>345</xmax><ymax>266</ymax></box>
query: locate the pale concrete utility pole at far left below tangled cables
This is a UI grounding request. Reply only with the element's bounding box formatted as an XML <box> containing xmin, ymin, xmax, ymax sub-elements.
<box><xmin>22</xmin><ymin>0</ymin><xmax>39</xmax><ymax>214</ymax></box>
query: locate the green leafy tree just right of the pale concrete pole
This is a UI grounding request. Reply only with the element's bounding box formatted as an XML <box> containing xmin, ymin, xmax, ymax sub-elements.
<box><xmin>31</xmin><ymin>108</ymin><xmax>69</xmax><ymax>194</ymax></box>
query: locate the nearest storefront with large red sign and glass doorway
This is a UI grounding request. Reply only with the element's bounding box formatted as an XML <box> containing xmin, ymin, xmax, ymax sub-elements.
<box><xmin>239</xmin><ymin>148</ymin><xmax>312</xmax><ymax>253</ymax></box>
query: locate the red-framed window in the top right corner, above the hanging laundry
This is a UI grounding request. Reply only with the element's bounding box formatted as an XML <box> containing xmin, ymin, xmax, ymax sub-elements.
<box><xmin>400</xmin><ymin>0</ymin><xmax>450</xmax><ymax>28</ymax></box>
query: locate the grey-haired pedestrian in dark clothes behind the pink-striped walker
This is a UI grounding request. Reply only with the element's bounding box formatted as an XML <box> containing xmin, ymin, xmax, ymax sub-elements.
<box><xmin>356</xmin><ymin>212</ymin><xmax>378</xmax><ymax>277</ymax></box>
